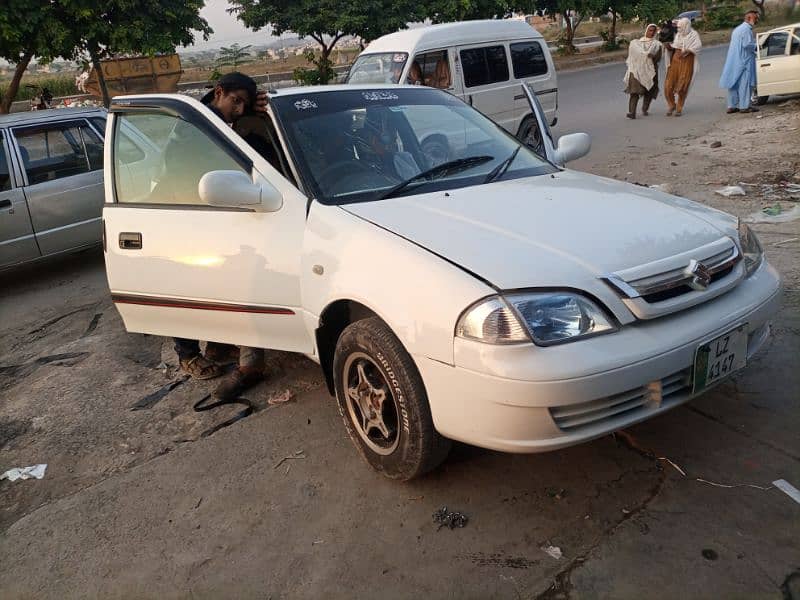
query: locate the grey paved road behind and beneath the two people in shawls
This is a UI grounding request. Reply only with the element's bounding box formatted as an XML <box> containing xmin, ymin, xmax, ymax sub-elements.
<box><xmin>553</xmin><ymin>46</ymin><xmax>727</xmax><ymax>171</ymax></box>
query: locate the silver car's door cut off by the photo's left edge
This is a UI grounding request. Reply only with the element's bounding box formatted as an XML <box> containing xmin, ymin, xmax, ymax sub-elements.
<box><xmin>0</xmin><ymin>131</ymin><xmax>40</xmax><ymax>268</ymax></box>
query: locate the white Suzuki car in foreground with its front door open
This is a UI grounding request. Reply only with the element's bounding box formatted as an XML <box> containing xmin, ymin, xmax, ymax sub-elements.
<box><xmin>103</xmin><ymin>85</ymin><xmax>781</xmax><ymax>479</ymax></box>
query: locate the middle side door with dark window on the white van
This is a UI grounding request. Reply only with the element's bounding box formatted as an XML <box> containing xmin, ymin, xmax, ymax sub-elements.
<box><xmin>457</xmin><ymin>42</ymin><xmax>519</xmax><ymax>135</ymax></box>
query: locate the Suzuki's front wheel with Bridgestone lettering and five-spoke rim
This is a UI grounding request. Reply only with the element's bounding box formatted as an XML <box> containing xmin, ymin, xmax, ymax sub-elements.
<box><xmin>333</xmin><ymin>317</ymin><xmax>451</xmax><ymax>481</ymax></box>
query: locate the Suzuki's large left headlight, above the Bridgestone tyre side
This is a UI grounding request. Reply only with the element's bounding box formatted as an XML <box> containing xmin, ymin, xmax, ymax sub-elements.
<box><xmin>456</xmin><ymin>292</ymin><xmax>616</xmax><ymax>346</ymax></box>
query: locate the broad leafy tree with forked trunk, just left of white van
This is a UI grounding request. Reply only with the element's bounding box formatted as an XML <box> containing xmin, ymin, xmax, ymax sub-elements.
<box><xmin>228</xmin><ymin>0</ymin><xmax>417</xmax><ymax>83</ymax></box>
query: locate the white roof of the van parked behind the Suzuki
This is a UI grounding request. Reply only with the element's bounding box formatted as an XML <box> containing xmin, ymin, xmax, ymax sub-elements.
<box><xmin>362</xmin><ymin>19</ymin><xmax>543</xmax><ymax>54</ymax></box>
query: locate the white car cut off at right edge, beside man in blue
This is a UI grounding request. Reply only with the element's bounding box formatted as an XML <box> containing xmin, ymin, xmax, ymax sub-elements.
<box><xmin>755</xmin><ymin>23</ymin><xmax>800</xmax><ymax>104</ymax></box>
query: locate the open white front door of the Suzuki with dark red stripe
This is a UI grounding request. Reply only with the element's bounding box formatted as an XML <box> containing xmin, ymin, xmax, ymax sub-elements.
<box><xmin>108</xmin><ymin>98</ymin><xmax>313</xmax><ymax>353</ymax></box>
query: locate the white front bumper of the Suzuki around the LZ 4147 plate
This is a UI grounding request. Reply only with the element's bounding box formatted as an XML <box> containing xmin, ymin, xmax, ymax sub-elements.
<box><xmin>414</xmin><ymin>262</ymin><xmax>780</xmax><ymax>453</ymax></box>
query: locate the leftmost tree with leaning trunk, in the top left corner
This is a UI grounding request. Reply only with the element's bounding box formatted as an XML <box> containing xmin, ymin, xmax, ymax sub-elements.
<box><xmin>0</xmin><ymin>0</ymin><xmax>72</xmax><ymax>114</ymax></box>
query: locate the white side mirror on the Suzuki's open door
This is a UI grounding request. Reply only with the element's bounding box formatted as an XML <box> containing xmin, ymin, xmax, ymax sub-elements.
<box><xmin>198</xmin><ymin>171</ymin><xmax>283</xmax><ymax>212</ymax></box>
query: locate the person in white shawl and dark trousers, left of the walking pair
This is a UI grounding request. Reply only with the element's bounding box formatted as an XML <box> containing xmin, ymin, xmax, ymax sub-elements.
<box><xmin>623</xmin><ymin>23</ymin><xmax>663</xmax><ymax>119</ymax></box>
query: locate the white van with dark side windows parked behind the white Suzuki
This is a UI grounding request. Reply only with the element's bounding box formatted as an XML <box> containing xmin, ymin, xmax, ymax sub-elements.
<box><xmin>346</xmin><ymin>19</ymin><xmax>558</xmax><ymax>141</ymax></box>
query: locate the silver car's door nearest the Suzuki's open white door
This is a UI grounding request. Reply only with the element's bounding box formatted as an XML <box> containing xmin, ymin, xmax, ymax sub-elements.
<box><xmin>12</xmin><ymin>119</ymin><xmax>104</xmax><ymax>255</ymax></box>
